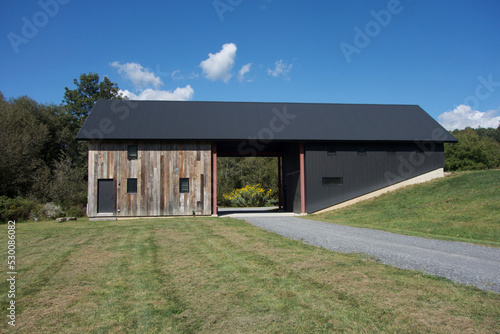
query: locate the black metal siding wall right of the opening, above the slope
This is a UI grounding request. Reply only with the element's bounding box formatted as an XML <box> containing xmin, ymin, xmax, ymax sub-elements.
<box><xmin>305</xmin><ymin>142</ymin><xmax>444</xmax><ymax>213</ymax></box>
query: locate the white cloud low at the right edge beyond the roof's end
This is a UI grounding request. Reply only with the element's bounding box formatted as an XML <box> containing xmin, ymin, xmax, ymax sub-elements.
<box><xmin>438</xmin><ymin>104</ymin><xmax>500</xmax><ymax>131</ymax></box>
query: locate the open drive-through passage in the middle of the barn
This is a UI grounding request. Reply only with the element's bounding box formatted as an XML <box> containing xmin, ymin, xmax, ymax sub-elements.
<box><xmin>212</xmin><ymin>141</ymin><xmax>301</xmax><ymax>215</ymax></box>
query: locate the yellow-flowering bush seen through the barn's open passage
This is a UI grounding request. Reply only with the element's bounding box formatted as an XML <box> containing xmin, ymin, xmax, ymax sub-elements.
<box><xmin>222</xmin><ymin>184</ymin><xmax>277</xmax><ymax>208</ymax></box>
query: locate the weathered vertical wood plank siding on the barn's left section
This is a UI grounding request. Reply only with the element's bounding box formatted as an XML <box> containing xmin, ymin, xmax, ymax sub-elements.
<box><xmin>88</xmin><ymin>141</ymin><xmax>212</xmax><ymax>217</ymax></box>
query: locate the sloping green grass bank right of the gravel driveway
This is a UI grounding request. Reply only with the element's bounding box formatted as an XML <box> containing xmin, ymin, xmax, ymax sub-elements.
<box><xmin>307</xmin><ymin>170</ymin><xmax>500</xmax><ymax>247</ymax></box>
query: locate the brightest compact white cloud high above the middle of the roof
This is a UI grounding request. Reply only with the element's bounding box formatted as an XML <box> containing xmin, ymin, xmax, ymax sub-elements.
<box><xmin>200</xmin><ymin>43</ymin><xmax>237</xmax><ymax>83</ymax></box>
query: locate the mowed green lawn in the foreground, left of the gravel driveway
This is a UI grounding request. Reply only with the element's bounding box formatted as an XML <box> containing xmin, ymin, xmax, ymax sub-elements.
<box><xmin>0</xmin><ymin>218</ymin><xmax>500</xmax><ymax>333</ymax></box>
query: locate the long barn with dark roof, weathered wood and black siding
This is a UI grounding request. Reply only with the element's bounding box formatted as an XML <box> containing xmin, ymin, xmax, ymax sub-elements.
<box><xmin>77</xmin><ymin>100</ymin><xmax>457</xmax><ymax>217</ymax></box>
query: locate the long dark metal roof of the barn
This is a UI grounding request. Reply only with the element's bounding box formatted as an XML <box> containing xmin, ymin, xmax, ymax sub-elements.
<box><xmin>77</xmin><ymin>100</ymin><xmax>457</xmax><ymax>142</ymax></box>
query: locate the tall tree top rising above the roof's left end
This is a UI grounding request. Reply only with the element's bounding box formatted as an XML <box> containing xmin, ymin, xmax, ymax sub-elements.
<box><xmin>63</xmin><ymin>73</ymin><xmax>122</xmax><ymax>123</ymax></box>
